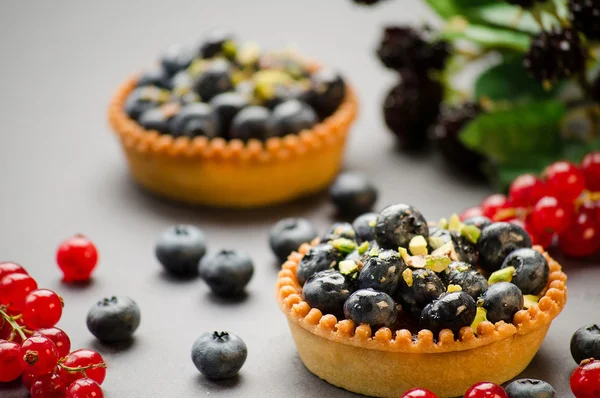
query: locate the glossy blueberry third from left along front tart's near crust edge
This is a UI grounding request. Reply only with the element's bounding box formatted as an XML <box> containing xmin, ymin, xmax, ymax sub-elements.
<box><xmin>421</xmin><ymin>292</ymin><xmax>477</xmax><ymax>336</ymax></box>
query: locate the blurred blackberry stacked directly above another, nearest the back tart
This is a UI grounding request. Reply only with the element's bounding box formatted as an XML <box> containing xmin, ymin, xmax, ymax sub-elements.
<box><xmin>377</xmin><ymin>26</ymin><xmax>450</xmax><ymax>74</ymax></box>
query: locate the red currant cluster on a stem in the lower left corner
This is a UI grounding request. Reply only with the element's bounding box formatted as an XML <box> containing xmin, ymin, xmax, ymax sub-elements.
<box><xmin>0</xmin><ymin>262</ymin><xmax>106</xmax><ymax>398</ymax></box>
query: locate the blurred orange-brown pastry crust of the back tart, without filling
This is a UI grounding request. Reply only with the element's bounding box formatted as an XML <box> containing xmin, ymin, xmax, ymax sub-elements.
<box><xmin>108</xmin><ymin>73</ymin><xmax>358</xmax><ymax>208</ymax></box>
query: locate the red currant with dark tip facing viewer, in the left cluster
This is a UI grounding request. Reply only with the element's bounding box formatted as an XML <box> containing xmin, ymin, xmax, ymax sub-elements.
<box><xmin>21</xmin><ymin>335</ymin><xmax>58</xmax><ymax>375</ymax></box>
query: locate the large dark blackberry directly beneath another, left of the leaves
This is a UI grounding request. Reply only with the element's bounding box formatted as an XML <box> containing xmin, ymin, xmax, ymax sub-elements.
<box><xmin>383</xmin><ymin>73</ymin><xmax>443</xmax><ymax>149</ymax></box>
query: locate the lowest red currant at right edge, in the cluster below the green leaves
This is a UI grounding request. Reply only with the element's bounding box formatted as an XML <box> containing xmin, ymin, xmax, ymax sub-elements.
<box><xmin>558</xmin><ymin>213</ymin><xmax>600</xmax><ymax>257</ymax></box>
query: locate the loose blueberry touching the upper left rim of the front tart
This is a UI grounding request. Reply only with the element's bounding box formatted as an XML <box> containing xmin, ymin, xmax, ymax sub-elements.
<box><xmin>269</xmin><ymin>218</ymin><xmax>318</xmax><ymax>262</ymax></box>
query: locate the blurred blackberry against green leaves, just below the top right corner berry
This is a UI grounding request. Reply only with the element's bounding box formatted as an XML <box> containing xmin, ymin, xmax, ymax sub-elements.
<box><xmin>523</xmin><ymin>29</ymin><xmax>585</xmax><ymax>83</ymax></box>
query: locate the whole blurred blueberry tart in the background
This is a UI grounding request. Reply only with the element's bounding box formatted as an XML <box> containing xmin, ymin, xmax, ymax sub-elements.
<box><xmin>108</xmin><ymin>31</ymin><xmax>358</xmax><ymax>208</ymax></box>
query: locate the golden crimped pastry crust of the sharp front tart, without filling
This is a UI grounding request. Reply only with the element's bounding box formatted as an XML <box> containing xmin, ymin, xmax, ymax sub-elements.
<box><xmin>277</xmin><ymin>241</ymin><xmax>567</xmax><ymax>397</ymax></box>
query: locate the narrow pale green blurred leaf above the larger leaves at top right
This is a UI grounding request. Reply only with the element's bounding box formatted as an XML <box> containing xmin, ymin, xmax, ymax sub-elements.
<box><xmin>440</xmin><ymin>19</ymin><xmax>530</xmax><ymax>53</ymax></box>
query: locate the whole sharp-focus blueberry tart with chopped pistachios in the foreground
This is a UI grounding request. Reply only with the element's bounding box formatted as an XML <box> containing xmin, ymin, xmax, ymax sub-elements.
<box><xmin>276</xmin><ymin>205</ymin><xmax>567</xmax><ymax>397</ymax></box>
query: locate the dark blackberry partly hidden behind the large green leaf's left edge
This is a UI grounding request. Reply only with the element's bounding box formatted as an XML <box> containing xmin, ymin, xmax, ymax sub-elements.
<box><xmin>432</xmin><ymin>103</ymin><xmax>485</xmax><ymax>178</ymax></box>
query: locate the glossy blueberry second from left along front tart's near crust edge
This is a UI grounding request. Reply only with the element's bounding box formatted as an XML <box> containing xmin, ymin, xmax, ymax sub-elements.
<box><xmin>344</xmin><ymin>289</ymin><xmax>398</xmax><ymax>329</ymax></box>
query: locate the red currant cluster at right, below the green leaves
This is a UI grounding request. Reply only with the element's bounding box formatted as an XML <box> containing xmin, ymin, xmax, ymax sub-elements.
<box><xmin>461</xmin><ymin>152</ymin><xmax>600</xmax><ymax>257</ymax></box>
